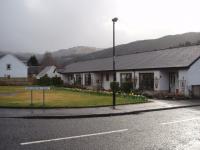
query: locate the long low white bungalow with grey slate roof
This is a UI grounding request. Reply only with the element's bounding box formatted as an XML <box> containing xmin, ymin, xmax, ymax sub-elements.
<box><xmin>62</xmin><ymin>46</ymin><xmax>200</xmax><ymax>96</ymax></box>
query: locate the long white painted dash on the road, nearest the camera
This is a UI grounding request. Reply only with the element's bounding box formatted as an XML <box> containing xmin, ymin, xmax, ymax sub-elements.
<box><xmin>20</xmin><ymin>129</ymin><xmax>128</xmax><ymax>145</ymax></box>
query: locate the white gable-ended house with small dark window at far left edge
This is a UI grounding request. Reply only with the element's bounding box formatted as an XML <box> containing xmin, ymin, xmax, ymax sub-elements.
<box><xmin>0</xmin><ymin>54</ymin><xmax>28</xmax><ymax>79</ymax></box>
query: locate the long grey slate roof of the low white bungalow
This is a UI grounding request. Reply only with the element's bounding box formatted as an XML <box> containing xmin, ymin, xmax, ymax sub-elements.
<box><xmin>63</xmin><ymin>46</ymin><xmax>200</xmax><ymax>73</ymax></box>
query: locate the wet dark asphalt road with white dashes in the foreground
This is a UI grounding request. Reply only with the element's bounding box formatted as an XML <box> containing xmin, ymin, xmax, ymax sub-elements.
<box><xmin>0</xmin><ymin>105</ymin><xmax>200</xmax><ymax>150</ymax></box>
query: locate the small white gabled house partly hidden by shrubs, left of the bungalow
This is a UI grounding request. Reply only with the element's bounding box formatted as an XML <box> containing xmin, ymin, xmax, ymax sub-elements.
<box><xmin>36</xmin><ymin>66</ymin><xmax>63</xmax><ymax>80</ymax></box>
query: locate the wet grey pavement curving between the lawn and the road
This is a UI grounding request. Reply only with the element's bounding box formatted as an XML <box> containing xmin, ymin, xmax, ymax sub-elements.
<box><xmin>0</xmin><ymin>99</ymin><xmax>200</xmax><ymax>119</ymax></box>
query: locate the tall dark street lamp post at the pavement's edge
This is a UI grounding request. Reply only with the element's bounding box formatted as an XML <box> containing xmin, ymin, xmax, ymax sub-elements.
<box><xmin>112</xmin><ymin>18</ymin><xmax>118</xmax><ymax>109</ymax></box>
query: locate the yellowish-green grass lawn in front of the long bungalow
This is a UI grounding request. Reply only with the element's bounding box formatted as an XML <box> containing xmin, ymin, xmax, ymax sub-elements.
<box><xmin>0</xmin><ymin>86</ymin><xmax>147</xmax><ymax>108</ymax></box>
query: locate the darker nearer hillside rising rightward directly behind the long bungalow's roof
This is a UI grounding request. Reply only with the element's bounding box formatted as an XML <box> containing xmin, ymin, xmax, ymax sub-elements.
<box><xmin>73</xmin><ymin>32</ymin><xmax>200</xmax><ymax>62</ymax></box>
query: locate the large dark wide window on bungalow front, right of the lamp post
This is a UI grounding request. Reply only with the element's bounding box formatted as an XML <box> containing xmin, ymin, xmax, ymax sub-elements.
<box><xmin>139</xmin><ymin>73</ymin><xmax>154</xmax><ymax>90</ymax></box>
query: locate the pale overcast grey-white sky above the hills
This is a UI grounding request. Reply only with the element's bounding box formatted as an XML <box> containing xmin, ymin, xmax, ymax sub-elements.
<box><xmin>0</xmin><ymin>0</ymin><xmax>200</xmax><ymax>52</ymax></box>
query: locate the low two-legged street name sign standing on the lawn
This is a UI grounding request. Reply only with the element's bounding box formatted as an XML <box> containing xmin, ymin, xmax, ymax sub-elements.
<box><xmin>25</xmin><ymin>86</ymin><xmax>50</xmax><ymax>107</ymax></box>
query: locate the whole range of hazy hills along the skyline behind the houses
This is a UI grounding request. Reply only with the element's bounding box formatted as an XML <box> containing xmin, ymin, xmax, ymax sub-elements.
<box><xmin>0</xmin><ymin>32</ymin><xmax>200</xmax><ymax>66</ymax></box>
